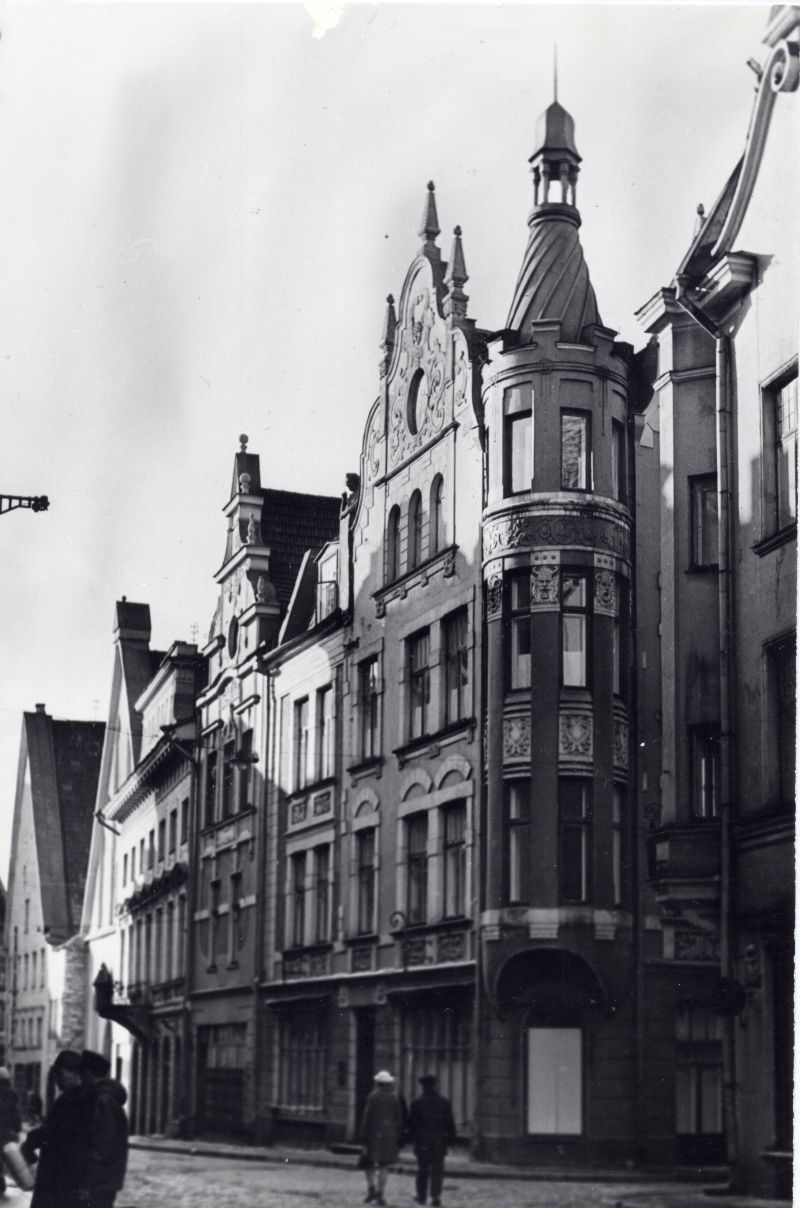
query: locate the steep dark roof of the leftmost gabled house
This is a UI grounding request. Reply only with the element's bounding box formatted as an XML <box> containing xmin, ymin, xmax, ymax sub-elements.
<box><xmin>10</xmin><ymin>709</ymin><xmax>105</xmax><ymax>942</ymax></box>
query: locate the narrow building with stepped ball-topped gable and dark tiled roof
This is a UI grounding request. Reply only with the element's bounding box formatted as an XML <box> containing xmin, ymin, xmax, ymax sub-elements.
<box><xmin>187</xmin><ymin>436</ymin><xmax>340</xmax><ymax>1136</ymax></box>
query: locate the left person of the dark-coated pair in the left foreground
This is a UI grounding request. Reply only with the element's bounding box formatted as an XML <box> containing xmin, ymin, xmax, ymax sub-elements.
<box><xmin>21</xmin><ymin>1049</ymin><xmax>88</xmax><ymax>1208</ymax></box>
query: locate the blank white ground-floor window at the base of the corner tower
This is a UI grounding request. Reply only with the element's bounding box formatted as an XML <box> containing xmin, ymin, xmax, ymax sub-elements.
<box><xmin>527</xmin><ymin>1024</ymin><xmax>584</xmax><ymax>1137</ymax></box>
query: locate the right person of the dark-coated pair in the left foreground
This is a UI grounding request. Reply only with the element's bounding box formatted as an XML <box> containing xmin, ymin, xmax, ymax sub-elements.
<box><xmin>76</xmin><ymin>1049</ymin><xmax>128</xmax><ymax>1208</ymax></box>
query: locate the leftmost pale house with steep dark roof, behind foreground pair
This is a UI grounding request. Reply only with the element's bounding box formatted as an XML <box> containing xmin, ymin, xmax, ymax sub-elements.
<box><xmin>6</xmin><ymin>704</ymin><xmax>105</xmax><ymax>1100</ymax></box>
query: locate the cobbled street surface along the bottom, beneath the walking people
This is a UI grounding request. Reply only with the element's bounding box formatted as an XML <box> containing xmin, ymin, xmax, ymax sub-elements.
<box><xmin>6</xmin><ymin>1145</ymin><xmax>785</xmax><ymax>1208</ymax></box>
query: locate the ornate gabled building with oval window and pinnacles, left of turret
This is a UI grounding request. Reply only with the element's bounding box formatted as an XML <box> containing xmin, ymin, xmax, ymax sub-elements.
<box><xmin>257</xmin><ymin>184</ymin><xmax>482</xmax><ymax>1140</ymax></box>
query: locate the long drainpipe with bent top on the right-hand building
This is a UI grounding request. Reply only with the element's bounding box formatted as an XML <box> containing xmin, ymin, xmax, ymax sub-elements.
<box><xmin>676</xmin><ymin>277</ymin><xmax>738</xmax><ymax>1186</ymax></box>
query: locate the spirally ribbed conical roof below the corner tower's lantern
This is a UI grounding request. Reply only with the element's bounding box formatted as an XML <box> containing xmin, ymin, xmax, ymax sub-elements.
<box><xmin>506</xmin><ymin>205</ymin><xmax>601</xmax><ymax>343</ymax></box>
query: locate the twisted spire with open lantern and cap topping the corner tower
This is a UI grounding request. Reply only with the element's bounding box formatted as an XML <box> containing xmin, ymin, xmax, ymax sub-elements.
<box><xmin>505</xmin><ymin>100</ymin><xmax>601</xmax><ymax>343</ymax></box>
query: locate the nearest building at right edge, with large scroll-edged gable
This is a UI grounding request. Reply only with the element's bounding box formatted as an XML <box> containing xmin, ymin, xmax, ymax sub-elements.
<box><xmin>637</xmin><ymin>6</ymin><xmax>800</xmax><ymax>1196</ymax></box>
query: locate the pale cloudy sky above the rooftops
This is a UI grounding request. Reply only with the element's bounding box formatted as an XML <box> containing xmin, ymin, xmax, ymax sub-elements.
<box><xmin>0</xmin><ymin>2</ymin><xmax>769</xmax><ymax>882</ymax></box>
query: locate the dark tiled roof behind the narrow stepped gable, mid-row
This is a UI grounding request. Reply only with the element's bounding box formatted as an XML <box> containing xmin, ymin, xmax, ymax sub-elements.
<box><xmin>261</xmin><ymin>490</ymin><xmax>342</xmax><ymax>612</ymax></box>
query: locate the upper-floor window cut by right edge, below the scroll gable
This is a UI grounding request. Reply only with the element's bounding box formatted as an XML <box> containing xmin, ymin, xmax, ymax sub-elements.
<box><xmin>761</xmin><ymin>366</ymin><xmax>798</xmax><ymax>536</ymax></box>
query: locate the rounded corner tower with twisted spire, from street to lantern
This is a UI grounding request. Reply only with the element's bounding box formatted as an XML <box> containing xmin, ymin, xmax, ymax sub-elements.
<box><xmin>476</xmin><ymin>101</ymin><xmax>634</xmax><ymax>1162</ymax></box>
